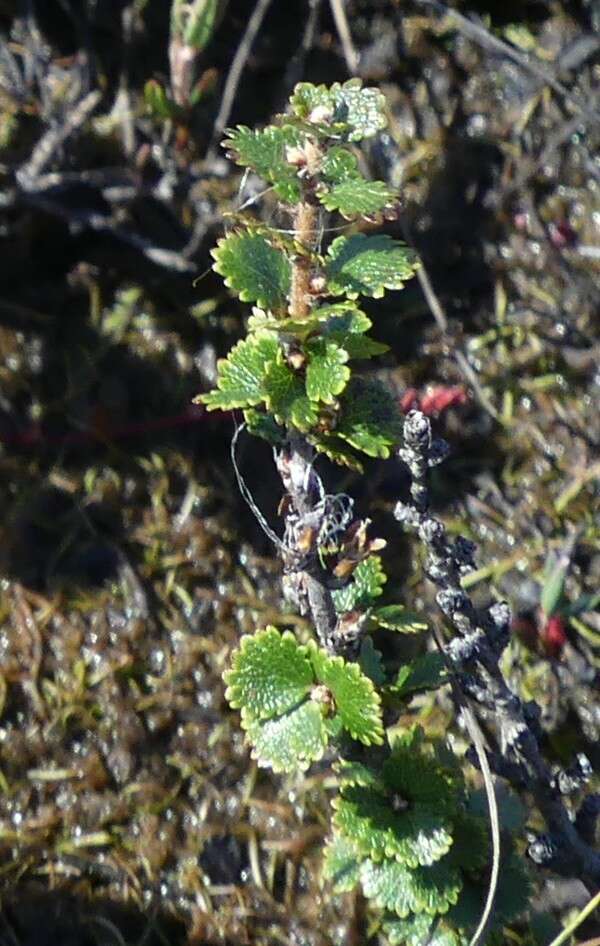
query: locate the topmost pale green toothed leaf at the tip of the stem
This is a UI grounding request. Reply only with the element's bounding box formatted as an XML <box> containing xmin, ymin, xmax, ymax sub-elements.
<box><xmin>290</xmin><ymin>79</ymin><xmax>387</xmax><ymax>141</ymax></box>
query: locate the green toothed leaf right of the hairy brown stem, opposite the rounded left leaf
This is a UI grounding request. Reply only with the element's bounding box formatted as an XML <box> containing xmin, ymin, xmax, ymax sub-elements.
<box><xmin>325</xmin><ymin>233</ymin><xmax>418</xmax><ymax>299</ymax></box>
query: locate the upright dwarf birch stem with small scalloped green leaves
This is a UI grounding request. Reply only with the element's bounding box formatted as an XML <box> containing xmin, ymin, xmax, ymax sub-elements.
<box><xmin>200</xmin><ymin>80</ymin><xmax>527</xmax><ymax>946</ymax></box>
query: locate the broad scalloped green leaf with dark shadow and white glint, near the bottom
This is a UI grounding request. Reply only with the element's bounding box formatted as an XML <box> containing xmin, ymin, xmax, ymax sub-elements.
<box><xmin>333</xmin><ymin>785</ymin><xmax>452</xmax><ymax>867</ymax></box>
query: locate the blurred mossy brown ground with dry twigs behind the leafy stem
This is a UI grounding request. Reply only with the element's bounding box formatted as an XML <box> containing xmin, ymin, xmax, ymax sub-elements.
<box><xmin>0</xmin><ymin>0</ymin><xmax>600</xmax><ymax>946</ymax></box>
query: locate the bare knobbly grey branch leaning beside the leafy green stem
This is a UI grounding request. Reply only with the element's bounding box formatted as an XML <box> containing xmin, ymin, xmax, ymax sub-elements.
<box><xmin>395</xmin><ymin>411</ymin><xmax>600</xmax><ymax>886</ymax></box>
